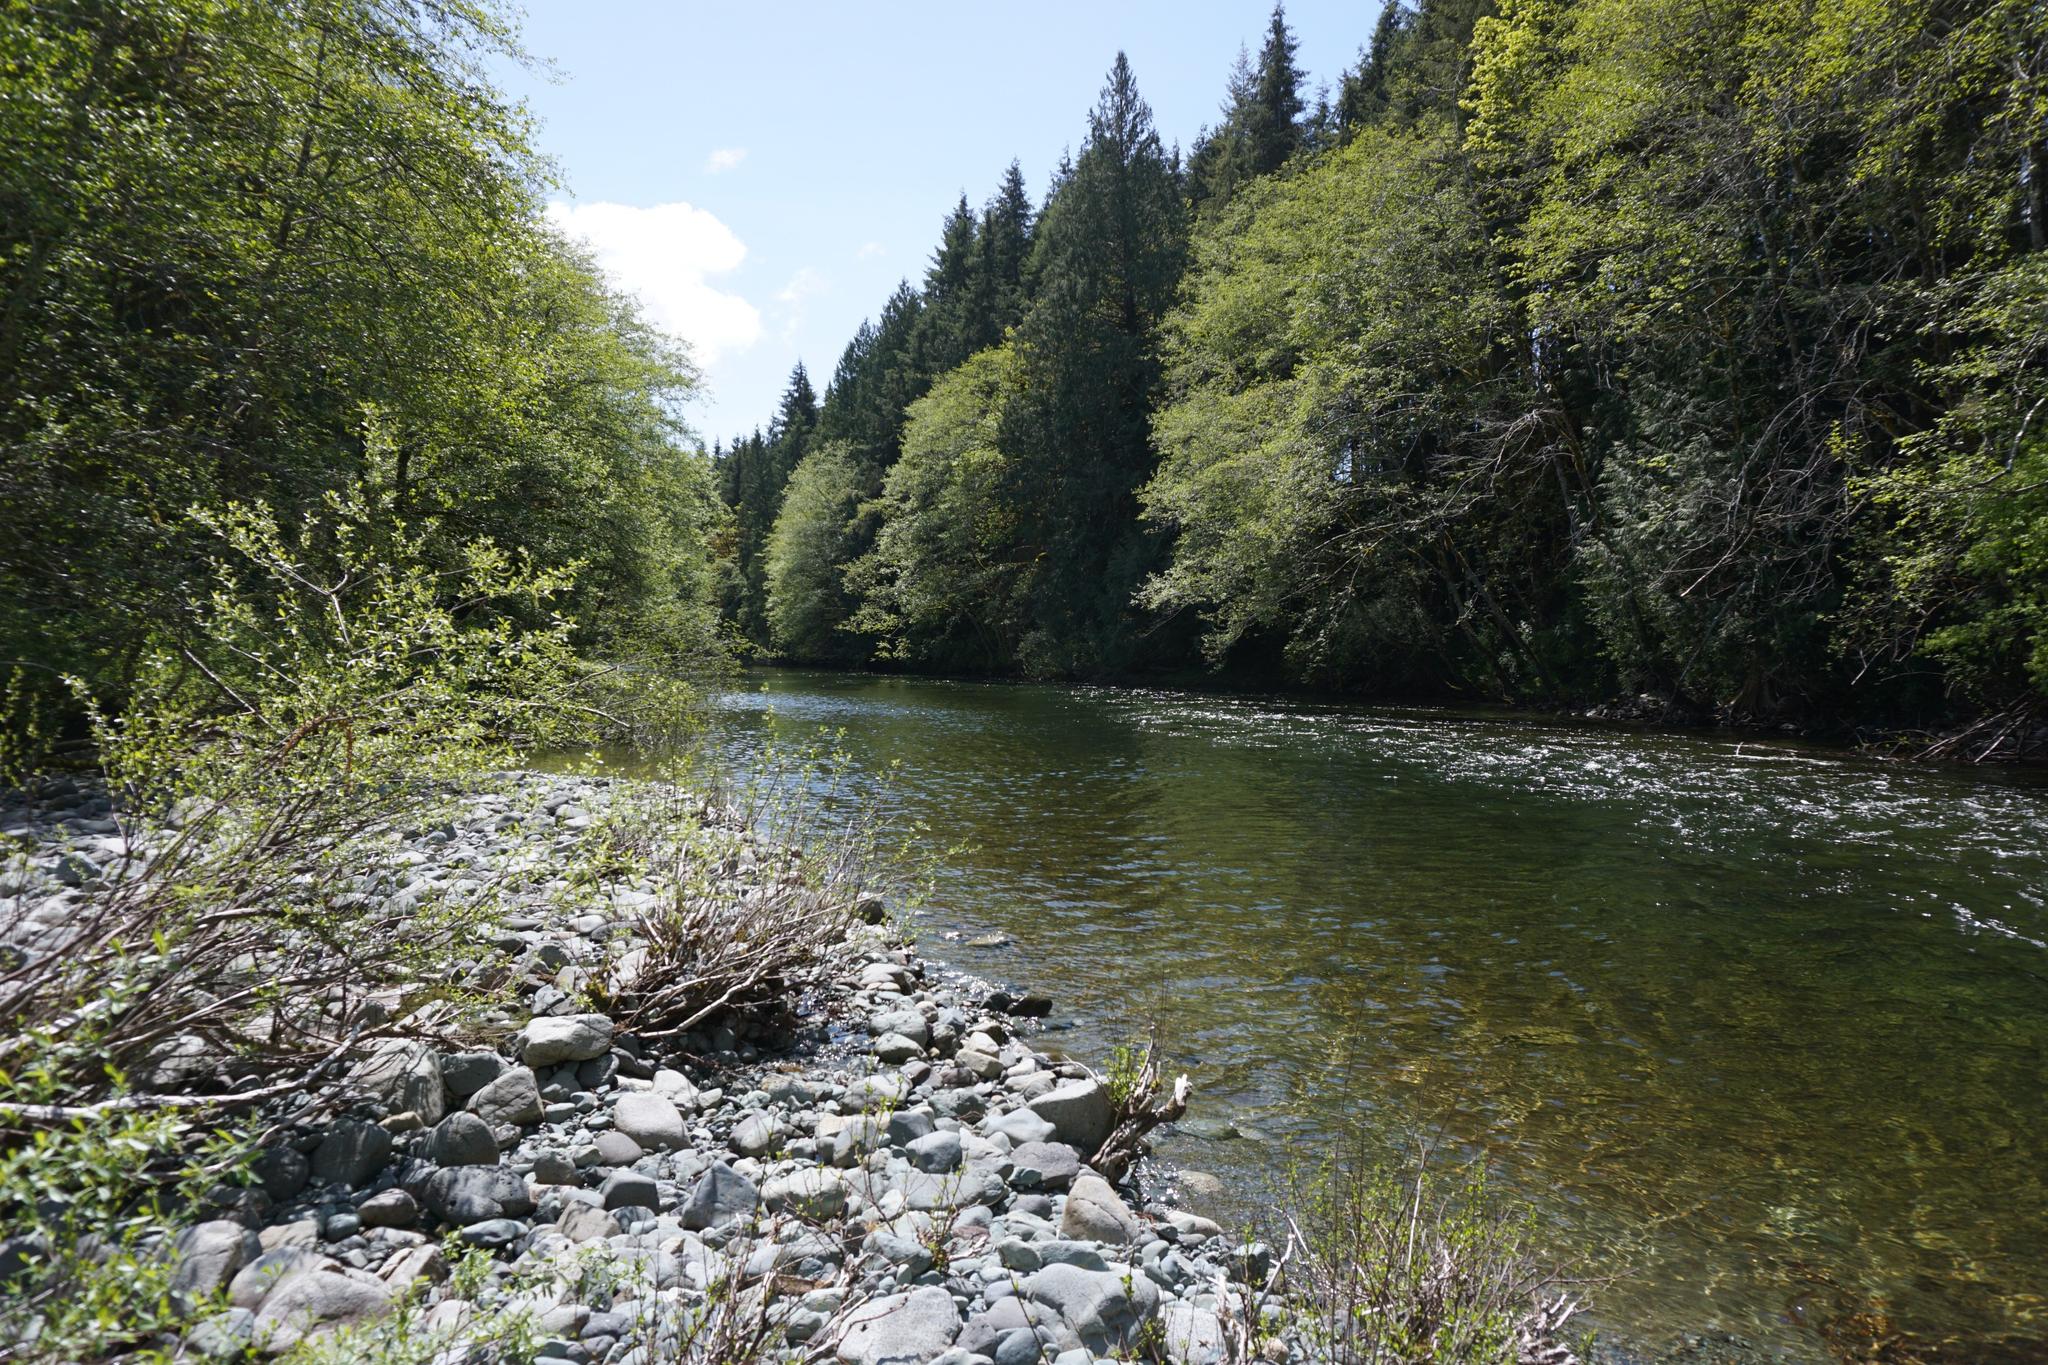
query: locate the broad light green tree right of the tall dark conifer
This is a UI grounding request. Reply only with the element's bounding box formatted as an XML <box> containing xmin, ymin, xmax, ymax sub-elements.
<box><xmin>1143</xmin><ymin>127</ymin><xmax>1569</xmax><ymax>696</ymax></box>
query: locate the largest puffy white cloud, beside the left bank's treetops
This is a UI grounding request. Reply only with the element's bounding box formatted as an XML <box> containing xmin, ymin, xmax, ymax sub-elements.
<box><xmin>547</xmin><ymin>203</ymin><xmax>762</xmax><ymax>364</ymax></box>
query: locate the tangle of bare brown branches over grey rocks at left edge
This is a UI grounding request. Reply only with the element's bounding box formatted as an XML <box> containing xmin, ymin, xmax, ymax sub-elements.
<box><xmin>0</xmin><ymin>765</ymin><xmax>512</xmax><ymax>1128</ymax></box>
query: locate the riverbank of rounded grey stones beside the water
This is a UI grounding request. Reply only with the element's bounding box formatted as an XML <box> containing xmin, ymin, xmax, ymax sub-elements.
<box><xmin>0</xmin><ymin>778</ymin><xmax>1277</xmax><ymax>1365</ymax></box>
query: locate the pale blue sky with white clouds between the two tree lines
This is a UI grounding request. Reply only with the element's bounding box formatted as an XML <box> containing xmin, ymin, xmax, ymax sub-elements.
<box><xmin>498</xmin><ymin>0</ymin><xmax>1378</xmax><ymax>444</ymax></box>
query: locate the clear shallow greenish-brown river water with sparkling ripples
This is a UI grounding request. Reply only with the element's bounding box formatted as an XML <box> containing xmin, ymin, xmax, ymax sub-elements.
<box><xmin>700</xmin><ymin>671</ymin><xmax>2048</xmax><ymax>1359</ymax></box>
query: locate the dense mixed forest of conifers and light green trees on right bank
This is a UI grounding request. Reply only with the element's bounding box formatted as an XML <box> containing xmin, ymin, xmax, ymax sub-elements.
<box><xmin>715</xmin><ymin>0</ymin><xmax>2048</xmax><ymax>753</ymax></box>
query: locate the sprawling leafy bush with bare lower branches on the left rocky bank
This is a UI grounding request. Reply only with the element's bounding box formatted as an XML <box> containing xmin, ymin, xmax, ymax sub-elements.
<box><xmin>0</xmin><ymin>495</ymin><xmax>688</xmax><ymax>1359</ymax></box>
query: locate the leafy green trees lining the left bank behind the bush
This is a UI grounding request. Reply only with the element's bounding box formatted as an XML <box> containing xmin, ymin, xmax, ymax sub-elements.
<box><xmin>0</xmin><ymin>0</ymin><xmax>725</xmax><ymax>740</ymax></box>
